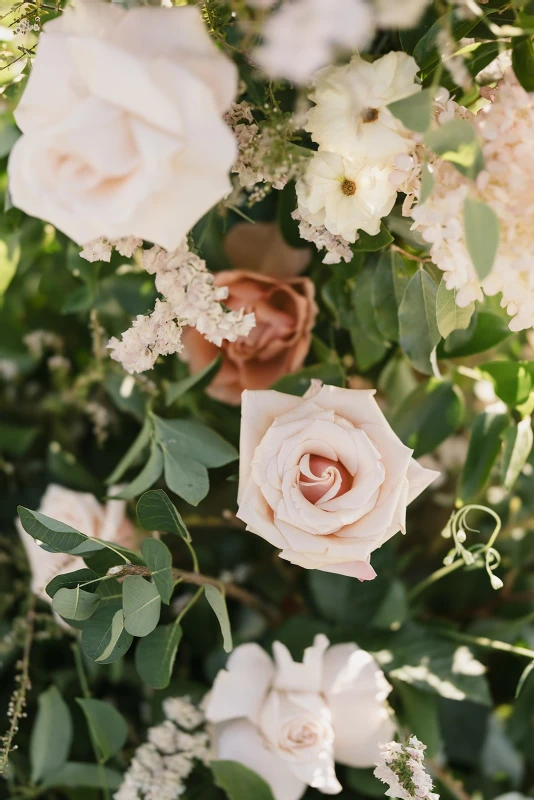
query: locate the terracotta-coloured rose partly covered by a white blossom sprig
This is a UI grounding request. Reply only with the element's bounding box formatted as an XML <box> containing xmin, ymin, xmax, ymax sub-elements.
<box><xmin>182</xmin><ymin>270</ymin><xmax>317</xmax><ymax>405</ymax></box>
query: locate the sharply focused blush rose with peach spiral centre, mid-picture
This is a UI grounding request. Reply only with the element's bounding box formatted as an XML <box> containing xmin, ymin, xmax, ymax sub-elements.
<box><xmin>237</xmin><ymin>381</ymin><xmax>439</xmax><ymax>580</ymax></box>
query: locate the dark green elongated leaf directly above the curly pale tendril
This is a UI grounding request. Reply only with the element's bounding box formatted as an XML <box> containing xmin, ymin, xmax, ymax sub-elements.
<box><xmin>458</xmin><ymin>411</ymin><xmax>510</xmax><ymax>503</ymax></box>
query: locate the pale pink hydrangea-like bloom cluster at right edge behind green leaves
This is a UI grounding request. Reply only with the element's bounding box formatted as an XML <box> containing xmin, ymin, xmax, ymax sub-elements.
<box><xmin>412</xmin><ymin>70</ymin><xmax>534</xmax><ymax>331</ymax></box>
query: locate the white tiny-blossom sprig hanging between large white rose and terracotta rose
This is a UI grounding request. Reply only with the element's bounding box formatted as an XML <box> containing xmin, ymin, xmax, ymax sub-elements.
<box><xmin>108</xmin><ymin>242</ymin><xmax>256</xmax><ymax>373</ymax></box>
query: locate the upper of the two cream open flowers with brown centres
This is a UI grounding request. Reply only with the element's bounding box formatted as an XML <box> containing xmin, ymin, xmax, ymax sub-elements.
<box><xmin>305</xmin><ymin>52</ymin><xmax>421</xmax><ymax>163</ymax></box>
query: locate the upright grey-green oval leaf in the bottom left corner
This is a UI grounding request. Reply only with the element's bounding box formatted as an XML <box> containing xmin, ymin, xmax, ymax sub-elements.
<box><xmin>30</xmin><ymin>686</ymin><xmax>72</xmax><ymax>783</ymax></box>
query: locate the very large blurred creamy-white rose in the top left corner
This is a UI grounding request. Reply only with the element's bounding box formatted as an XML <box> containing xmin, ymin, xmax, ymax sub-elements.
<box><xmin>9</xmin><ymin>2</ymin><xmax>237</xmax><ymax>250</ymax></box>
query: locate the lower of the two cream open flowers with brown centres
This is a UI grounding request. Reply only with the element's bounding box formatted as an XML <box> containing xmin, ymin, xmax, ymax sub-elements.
<box><xmin>297</xmin><ymin>151</ymin><xmax>397</xmax><ymax>242</ymax></box>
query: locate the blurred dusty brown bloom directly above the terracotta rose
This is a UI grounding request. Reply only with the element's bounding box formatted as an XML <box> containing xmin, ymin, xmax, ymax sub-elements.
<box><xmin>223</xmin><ymin>222</ymin><xmax>311</xmax><ymax>278</ymax></box>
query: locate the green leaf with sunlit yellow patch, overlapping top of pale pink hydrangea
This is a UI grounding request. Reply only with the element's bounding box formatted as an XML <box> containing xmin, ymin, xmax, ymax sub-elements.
<box><xmin>425</xmin><ymin>119</ymin><xmax>484</xmax><ymax>178</ymax></box>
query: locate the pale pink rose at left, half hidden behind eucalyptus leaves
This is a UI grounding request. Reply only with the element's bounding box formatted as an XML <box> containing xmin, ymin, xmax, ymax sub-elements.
<box><xmin>17</xmin><ymin>483</ymin><xmax>137</xmax><ymax>603</ymax></box>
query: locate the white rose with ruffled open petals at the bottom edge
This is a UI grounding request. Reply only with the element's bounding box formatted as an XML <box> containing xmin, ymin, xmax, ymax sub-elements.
<box><xmin>206</xmin><ymin>635</ymin><xmax>394</xmax><ymax>800</ymax></box>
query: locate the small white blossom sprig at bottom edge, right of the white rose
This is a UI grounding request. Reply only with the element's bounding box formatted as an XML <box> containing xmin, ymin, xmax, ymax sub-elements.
<box><xmin>374</xmin><ymin>736</ymin><xmax>439</xmax><ymax>800</ymax></box>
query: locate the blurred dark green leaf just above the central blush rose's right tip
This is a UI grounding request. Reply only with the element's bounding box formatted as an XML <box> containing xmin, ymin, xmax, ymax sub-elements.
<box><xmin>391</xmin><ymin>378</ymin><xmax>465</xmax><ymax>458</ymax></box>
